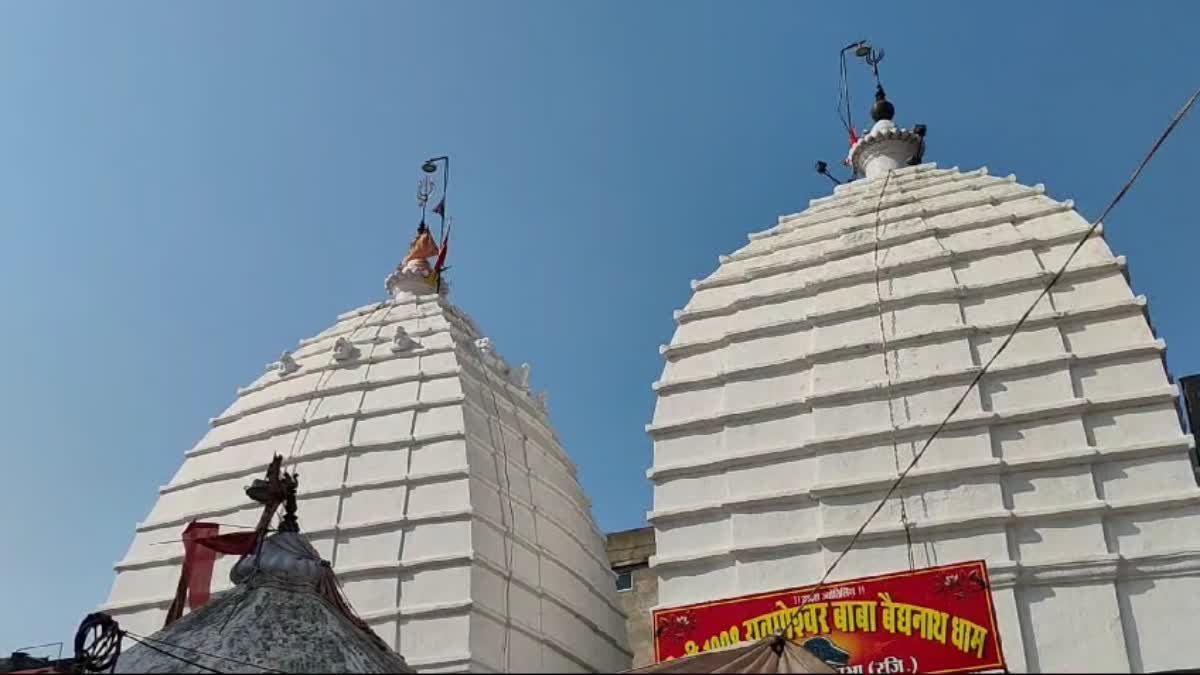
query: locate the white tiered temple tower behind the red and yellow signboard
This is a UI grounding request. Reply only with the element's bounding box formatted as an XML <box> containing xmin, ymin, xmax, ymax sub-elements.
<box><xmin>647</xmin><ymin>165</ymin><xmax>1200</xmax><ymax>673</ymax></box>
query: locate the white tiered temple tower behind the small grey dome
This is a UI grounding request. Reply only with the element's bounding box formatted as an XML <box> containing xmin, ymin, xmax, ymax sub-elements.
<box><xmin>102</xmin><ymin>293</ymin><xmax>631</xmax><ymax>673</ymax></box>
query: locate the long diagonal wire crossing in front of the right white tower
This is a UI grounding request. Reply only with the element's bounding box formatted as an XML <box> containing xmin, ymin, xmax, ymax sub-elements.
<box><xmin>784</xmin><ymin>89</ymin><xmax>1200</xmax><ymax>632</ymax></box>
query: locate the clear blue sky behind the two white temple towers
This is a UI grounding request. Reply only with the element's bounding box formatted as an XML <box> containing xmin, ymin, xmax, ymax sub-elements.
<box><xmin>0</xmin><ymin>0</ymin><xmax>1200</xmax><ymax>653</ymax></box>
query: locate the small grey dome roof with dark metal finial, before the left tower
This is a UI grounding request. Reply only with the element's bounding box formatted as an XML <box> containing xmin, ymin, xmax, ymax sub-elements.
<box><xmin>93</xmin><ymin>455</ymin><xmax>413</xmax><ymax>673</ymax></box>
